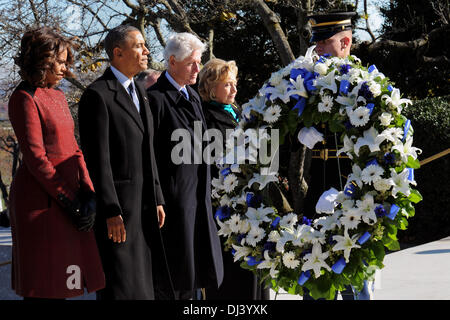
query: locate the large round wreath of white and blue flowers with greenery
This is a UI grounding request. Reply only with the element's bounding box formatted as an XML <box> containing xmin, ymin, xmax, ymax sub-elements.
<box><xmin>212</xmin><ymin>47</ymin><xmax>422</xmax><ymax>299</ymax></box>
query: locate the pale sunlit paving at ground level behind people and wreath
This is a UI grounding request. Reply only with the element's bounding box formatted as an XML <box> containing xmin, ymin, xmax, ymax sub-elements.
<box><xmin>0</xmin><ymin>227</ymin><xmax>450</xmax><ymax>300</ymax></box>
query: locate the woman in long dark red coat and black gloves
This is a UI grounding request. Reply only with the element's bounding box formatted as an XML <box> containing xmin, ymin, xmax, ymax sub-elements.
<box><xmin>8</xmin><ymin>27</ymin><xmax>105</xmax><ymax>299</ymax></box>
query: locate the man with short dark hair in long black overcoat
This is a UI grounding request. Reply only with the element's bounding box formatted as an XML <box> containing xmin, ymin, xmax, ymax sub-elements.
<box><xmin>79</xmin><ymin>26</ymin><xmax>171</xmax><ymax>300</ymax></box>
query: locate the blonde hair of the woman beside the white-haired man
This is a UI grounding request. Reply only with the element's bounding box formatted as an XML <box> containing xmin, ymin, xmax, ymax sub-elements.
<box><xmin>198</xmin><ymin>59</ymin><xmax>238</xmax><ymax>102</ymax></box>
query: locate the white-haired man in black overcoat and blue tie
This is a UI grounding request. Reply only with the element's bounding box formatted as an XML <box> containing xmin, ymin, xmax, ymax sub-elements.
<box><xmin>147</xmin><ymin>33</ymin><xmax>223</xmax><ymax>299</ymax></box>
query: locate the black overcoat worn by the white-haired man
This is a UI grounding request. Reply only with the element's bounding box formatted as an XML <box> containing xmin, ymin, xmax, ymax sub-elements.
<box><xmin>147</xmin><ymin>72</ymin><xmax>223</xmax><ymax>291</ymax></box>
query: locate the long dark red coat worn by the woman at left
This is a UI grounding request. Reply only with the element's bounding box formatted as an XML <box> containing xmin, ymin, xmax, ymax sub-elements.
<box><xmin>8</xmin><ymin>82</ymin><xmax>105</xmax><ymax>298</ymax></box>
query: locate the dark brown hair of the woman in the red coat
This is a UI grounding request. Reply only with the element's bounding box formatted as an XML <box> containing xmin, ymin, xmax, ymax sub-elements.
<box><xmin>14</xmin><ymin>27</ymin><xmax>75</xmax><ymax>88</ymax></box>
